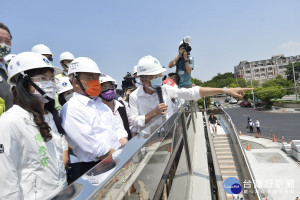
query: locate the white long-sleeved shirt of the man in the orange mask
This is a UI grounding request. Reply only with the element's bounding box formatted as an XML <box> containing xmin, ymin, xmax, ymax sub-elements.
<box><xmin>60</xmin><ymin>92</ymin><xmax>127</xmax><ymax>162</ymax></box>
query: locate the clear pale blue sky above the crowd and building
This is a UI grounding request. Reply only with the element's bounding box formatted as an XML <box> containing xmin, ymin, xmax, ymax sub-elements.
<box><xmin>0</xmin><ymin>0</ymin><xmax>300</xmax><ymax>87</ymax></box>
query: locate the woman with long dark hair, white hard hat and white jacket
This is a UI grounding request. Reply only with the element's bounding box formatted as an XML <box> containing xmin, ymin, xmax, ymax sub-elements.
<box><xmin>0</xmin><ymin>52</ymin><xmax>67</xmax><ymax>199</ymax></box>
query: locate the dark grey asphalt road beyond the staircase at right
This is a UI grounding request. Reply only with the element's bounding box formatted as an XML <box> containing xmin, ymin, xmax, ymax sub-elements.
<box><xmin>212</xmin><ymin>97</ymin><xmax>300</xmax><ymax>140</ymax></box>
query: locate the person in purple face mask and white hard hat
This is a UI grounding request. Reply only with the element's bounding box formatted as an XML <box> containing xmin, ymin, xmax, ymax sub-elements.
<box><xmin>100</xmin><ymin>75</ymin><xmax>135</xmax><ymax>140</ymax></box>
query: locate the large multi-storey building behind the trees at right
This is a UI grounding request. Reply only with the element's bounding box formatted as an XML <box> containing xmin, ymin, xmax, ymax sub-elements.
<box><xmin>234</xmin><ymin>54</ymin><xmax>300</xmax><ymax>83</ymax></box>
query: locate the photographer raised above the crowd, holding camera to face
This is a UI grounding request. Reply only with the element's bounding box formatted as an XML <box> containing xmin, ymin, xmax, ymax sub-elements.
<box><xmin>169</xmin><ymin>36</ymin><xmax>194</xmax><ymax>88</ymax></box>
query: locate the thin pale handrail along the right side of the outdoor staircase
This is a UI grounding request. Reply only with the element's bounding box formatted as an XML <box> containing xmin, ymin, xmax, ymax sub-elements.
<box><xmin>221</xmin><ymin>108</ymin><xmax>261</xmax><ymax>199</ymax></box>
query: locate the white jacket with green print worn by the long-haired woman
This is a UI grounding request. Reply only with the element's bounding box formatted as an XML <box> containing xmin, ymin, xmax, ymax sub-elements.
<box><xmin>0</xmin><ymin>105</ymin><xmax>67</xmax><ymax>200</ymax></box>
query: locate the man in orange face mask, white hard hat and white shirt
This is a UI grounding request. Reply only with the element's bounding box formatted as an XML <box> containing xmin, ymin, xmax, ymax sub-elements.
<box><xmin>61</xmin><ymin>57</ymin><xmax>128</xmax><ymax>174</ymax></box>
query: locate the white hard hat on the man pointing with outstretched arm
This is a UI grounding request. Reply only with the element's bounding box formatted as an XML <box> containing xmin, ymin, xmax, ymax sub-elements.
<box><xmin>137</xmin><ymin>56</ymin><xmax>166</xmax><ymax>76</ymax></box>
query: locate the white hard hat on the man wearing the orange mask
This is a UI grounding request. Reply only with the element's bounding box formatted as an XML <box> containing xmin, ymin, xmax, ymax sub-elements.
<box><xmin>68</xmin><ymin>57</ymin><xmax>101</xmax><ymax>75</ymax></box>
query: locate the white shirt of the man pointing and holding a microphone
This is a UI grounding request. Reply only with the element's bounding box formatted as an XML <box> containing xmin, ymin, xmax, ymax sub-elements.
<box><xmin>129</xmin><ymin>85</ymin><xmax>201</xmax><ymax>129</ymax></box>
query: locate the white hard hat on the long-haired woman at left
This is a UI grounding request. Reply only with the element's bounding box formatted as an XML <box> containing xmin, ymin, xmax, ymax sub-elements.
<box><xmin>7</xmin><ymin>52</ymin><xmax>62</xmax><ymax>85</ymax></box>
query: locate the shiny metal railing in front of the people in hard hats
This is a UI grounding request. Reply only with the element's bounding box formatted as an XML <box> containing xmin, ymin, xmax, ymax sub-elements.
<box><xmin>53</xmin><ymin>102</ymin><xmax>197</xmax><ymax>200</ymax></box>
